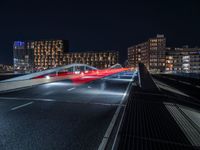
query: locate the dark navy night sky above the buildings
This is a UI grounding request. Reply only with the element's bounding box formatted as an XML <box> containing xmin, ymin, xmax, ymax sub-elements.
<box><xmin>0</xmin><ymin>0</ymin><xmax>200</xmax><ymax>64</ymax></box>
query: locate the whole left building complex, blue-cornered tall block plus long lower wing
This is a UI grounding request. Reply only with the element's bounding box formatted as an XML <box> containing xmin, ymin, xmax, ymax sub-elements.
<box><xmin>13</xmin><ymin>40</ymin><xmax>118</xmax><ymax>73</ymax></box>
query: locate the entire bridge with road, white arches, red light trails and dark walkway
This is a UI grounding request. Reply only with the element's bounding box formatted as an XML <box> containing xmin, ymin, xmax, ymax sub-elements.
<box><xmin>0</xmin><ymin>64</ymin><xmax>200</xmax><ymax>150</ymax></box>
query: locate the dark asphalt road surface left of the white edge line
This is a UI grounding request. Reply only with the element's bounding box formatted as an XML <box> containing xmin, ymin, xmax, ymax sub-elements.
<box><xmin>0</xmin><ymin>73</ymin><xmax>135</xmax><ymax>150</ymax></box>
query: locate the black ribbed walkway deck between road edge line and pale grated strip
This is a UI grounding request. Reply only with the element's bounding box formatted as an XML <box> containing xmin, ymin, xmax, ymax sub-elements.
<box><xmin>118</xmin><ymin>88</ymin><xmax>194</xmax><ymax>150</ymax></box>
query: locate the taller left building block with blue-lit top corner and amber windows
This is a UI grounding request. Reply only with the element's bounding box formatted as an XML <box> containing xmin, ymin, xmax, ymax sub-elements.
<box><xmin>13</xmin><ymin>40</ymin><xmax>69</xmax><ymax>72</ymax></box>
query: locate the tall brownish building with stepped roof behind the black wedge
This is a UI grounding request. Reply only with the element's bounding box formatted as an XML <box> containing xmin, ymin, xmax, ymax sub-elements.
<box><xmin>128</xmin><ymin>35</ymin><xmax>166</xmax><ymax>72</ymax></box>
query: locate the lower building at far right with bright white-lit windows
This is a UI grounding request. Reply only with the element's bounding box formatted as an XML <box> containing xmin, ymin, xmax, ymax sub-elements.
<box><xmin>166</xmin><ymin>47</ymin><xmax>200</xmax><ymax>73</ymax></box>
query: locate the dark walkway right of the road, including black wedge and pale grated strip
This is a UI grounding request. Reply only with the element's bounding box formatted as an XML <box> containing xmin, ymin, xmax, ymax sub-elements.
<box><xmin>113</xmin><ymin>65</ymin><xmax>200</xmax><ymax>150</ymax></box>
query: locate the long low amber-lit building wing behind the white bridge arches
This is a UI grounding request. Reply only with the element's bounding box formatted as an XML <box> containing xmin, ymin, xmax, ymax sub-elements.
<box><xmin>63</xmin><ymin>51</ymin><xmax>118</xmax><ymax>69</ymax></box>
